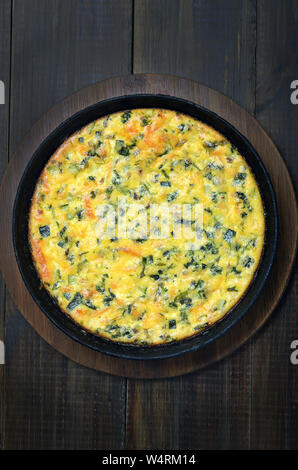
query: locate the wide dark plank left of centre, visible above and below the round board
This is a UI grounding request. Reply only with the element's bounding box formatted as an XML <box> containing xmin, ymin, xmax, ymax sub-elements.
<box><xmin>5</xmin><ymin>0</ymin><xmax>131</xmax><ymax>449</ymax></box>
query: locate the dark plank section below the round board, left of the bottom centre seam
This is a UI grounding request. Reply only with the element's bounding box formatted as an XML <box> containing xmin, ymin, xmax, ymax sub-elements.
<box><xmin>5</xmin><ymin>301</ymin><xmax>125</xmax><ymax>449</ymax></box>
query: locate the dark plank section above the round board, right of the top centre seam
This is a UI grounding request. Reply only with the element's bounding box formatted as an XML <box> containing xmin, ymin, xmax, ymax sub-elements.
<box><xmin>133</xmin><ymin>0</ymin><xmax>256</xmax><ymax>112</ymax></box>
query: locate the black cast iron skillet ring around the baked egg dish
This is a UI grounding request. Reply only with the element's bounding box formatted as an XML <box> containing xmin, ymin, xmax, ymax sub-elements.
<box><xmin>13</xmin><ymin>94</ymin><xmax>277</xmax><ymax>359</ymax></box>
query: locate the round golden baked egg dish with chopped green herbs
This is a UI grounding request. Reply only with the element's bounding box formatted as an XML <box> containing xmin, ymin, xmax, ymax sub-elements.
<box><xmin>29</xmin><ymin>108</ymin><xmax>265</xmax><ymax>345</ymax></box>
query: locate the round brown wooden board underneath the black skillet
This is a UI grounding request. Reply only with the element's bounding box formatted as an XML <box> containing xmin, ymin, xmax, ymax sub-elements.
<box><xmin>0</xmin><ymin>74</ymin><xmax>297</xmax><ymax>379</ymax></box>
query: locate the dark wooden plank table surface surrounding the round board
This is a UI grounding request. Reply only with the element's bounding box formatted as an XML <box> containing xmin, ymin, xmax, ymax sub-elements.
<box><xmin>0</xmin><ymin>0</ymin><xmax>298</xmax><ymax>449</ymax></box>
